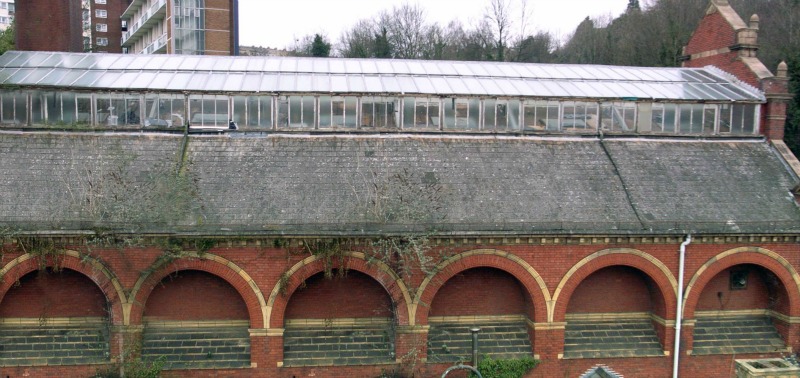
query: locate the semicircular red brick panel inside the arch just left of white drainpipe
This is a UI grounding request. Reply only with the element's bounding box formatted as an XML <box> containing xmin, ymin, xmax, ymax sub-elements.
<box><xmin>567</xmin><ymin>266</ymin><xmax>661</xmax><ymax>313</ymax></box>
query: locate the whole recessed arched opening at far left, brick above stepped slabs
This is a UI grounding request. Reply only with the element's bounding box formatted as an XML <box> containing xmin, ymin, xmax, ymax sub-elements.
<box><xmin>0</xmin><ymin>268</ymin><xmax>110</xmax><ymax>366</ymax></box>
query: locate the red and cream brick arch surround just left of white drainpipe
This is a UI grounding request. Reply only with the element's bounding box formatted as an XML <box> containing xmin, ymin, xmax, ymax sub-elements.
<box><xmin>548</xmin><ymin>248</ymin><xmax>678</xmax><ymax>322</ymax></box>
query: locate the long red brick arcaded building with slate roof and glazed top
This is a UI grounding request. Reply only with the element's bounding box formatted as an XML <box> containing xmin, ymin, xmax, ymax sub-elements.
<box><xmin>0</xmin><ymin>0</ymin><xmax>800</xmax><ymax>377</ymax></box>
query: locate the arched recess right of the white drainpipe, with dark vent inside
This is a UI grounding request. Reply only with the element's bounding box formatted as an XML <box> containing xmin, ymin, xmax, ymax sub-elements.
<box><xmin>692</xmin><ymin>264</ymin><xmax>789</xmax><ymax>354</ymax></box>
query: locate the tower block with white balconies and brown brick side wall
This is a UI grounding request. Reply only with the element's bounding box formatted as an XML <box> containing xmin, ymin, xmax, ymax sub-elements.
<box><xmin>122</xmin><ymin>0</ymin><xmax>238</xmax><ymax>55</ymax></box>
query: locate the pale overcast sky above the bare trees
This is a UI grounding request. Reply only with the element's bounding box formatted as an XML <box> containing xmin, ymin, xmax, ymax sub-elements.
<box><xmin>239</xmin><ymin>0</ymin><xmax>632</xmax><ymax>48</ymax></box>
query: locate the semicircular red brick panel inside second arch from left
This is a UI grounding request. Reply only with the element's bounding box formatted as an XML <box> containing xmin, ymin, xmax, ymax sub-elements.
<box><xmin>144</xmin><ymin>270</ymin><xmax>245</xmax><ymax>320</ymax></box>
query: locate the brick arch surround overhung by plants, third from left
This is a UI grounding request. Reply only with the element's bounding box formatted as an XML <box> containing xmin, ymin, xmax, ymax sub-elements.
<box><xmin>266</xmin><ymin>252</ymin><xmax>414</xmax><ymax>328</ymax></box>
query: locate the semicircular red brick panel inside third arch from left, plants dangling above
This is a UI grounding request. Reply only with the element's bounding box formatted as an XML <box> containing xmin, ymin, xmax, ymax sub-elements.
<box><xmin>285</xmin><ymin>271</ymin><xmax>392</xmax><ymax>319</ymax></box>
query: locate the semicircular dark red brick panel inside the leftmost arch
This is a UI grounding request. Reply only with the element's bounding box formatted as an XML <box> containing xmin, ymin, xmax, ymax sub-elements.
<box><xmin>0</xmin><ymin>269</ymin><xmax>108</xmax><ymax>318</ymax></box>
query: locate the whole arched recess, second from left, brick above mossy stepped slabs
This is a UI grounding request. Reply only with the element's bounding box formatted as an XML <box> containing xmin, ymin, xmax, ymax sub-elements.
<box><xmin>142</xmin><ymin>270</ymin><xmax>250</xmax><ymax>369</ymax></box>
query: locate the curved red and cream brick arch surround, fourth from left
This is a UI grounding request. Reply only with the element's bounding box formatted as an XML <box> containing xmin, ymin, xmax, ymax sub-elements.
<box><xmin>412</xmin><ymin>249</ymin><xmax>551</xmax><ymax>324</ymax></box>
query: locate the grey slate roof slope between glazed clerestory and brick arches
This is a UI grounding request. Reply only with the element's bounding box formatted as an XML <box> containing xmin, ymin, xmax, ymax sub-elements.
<box><xmin>0</xmin><ymin>133</ymin><xmax>800</xmax><ymax>235</ymax></box>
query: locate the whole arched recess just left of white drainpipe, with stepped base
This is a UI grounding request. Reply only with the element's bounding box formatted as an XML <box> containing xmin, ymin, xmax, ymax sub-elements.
<box><xmin>564</xmin><ymin>266</ymin><xmax>666</xmax><ymax>358</ymax></box>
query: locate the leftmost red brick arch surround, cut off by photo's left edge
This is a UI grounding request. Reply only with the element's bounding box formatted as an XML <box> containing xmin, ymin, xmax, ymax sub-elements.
<box><xmin>0</xmin><ymin>250</ymin><xmax>128</xmax><ymax>324</ymax></box>
